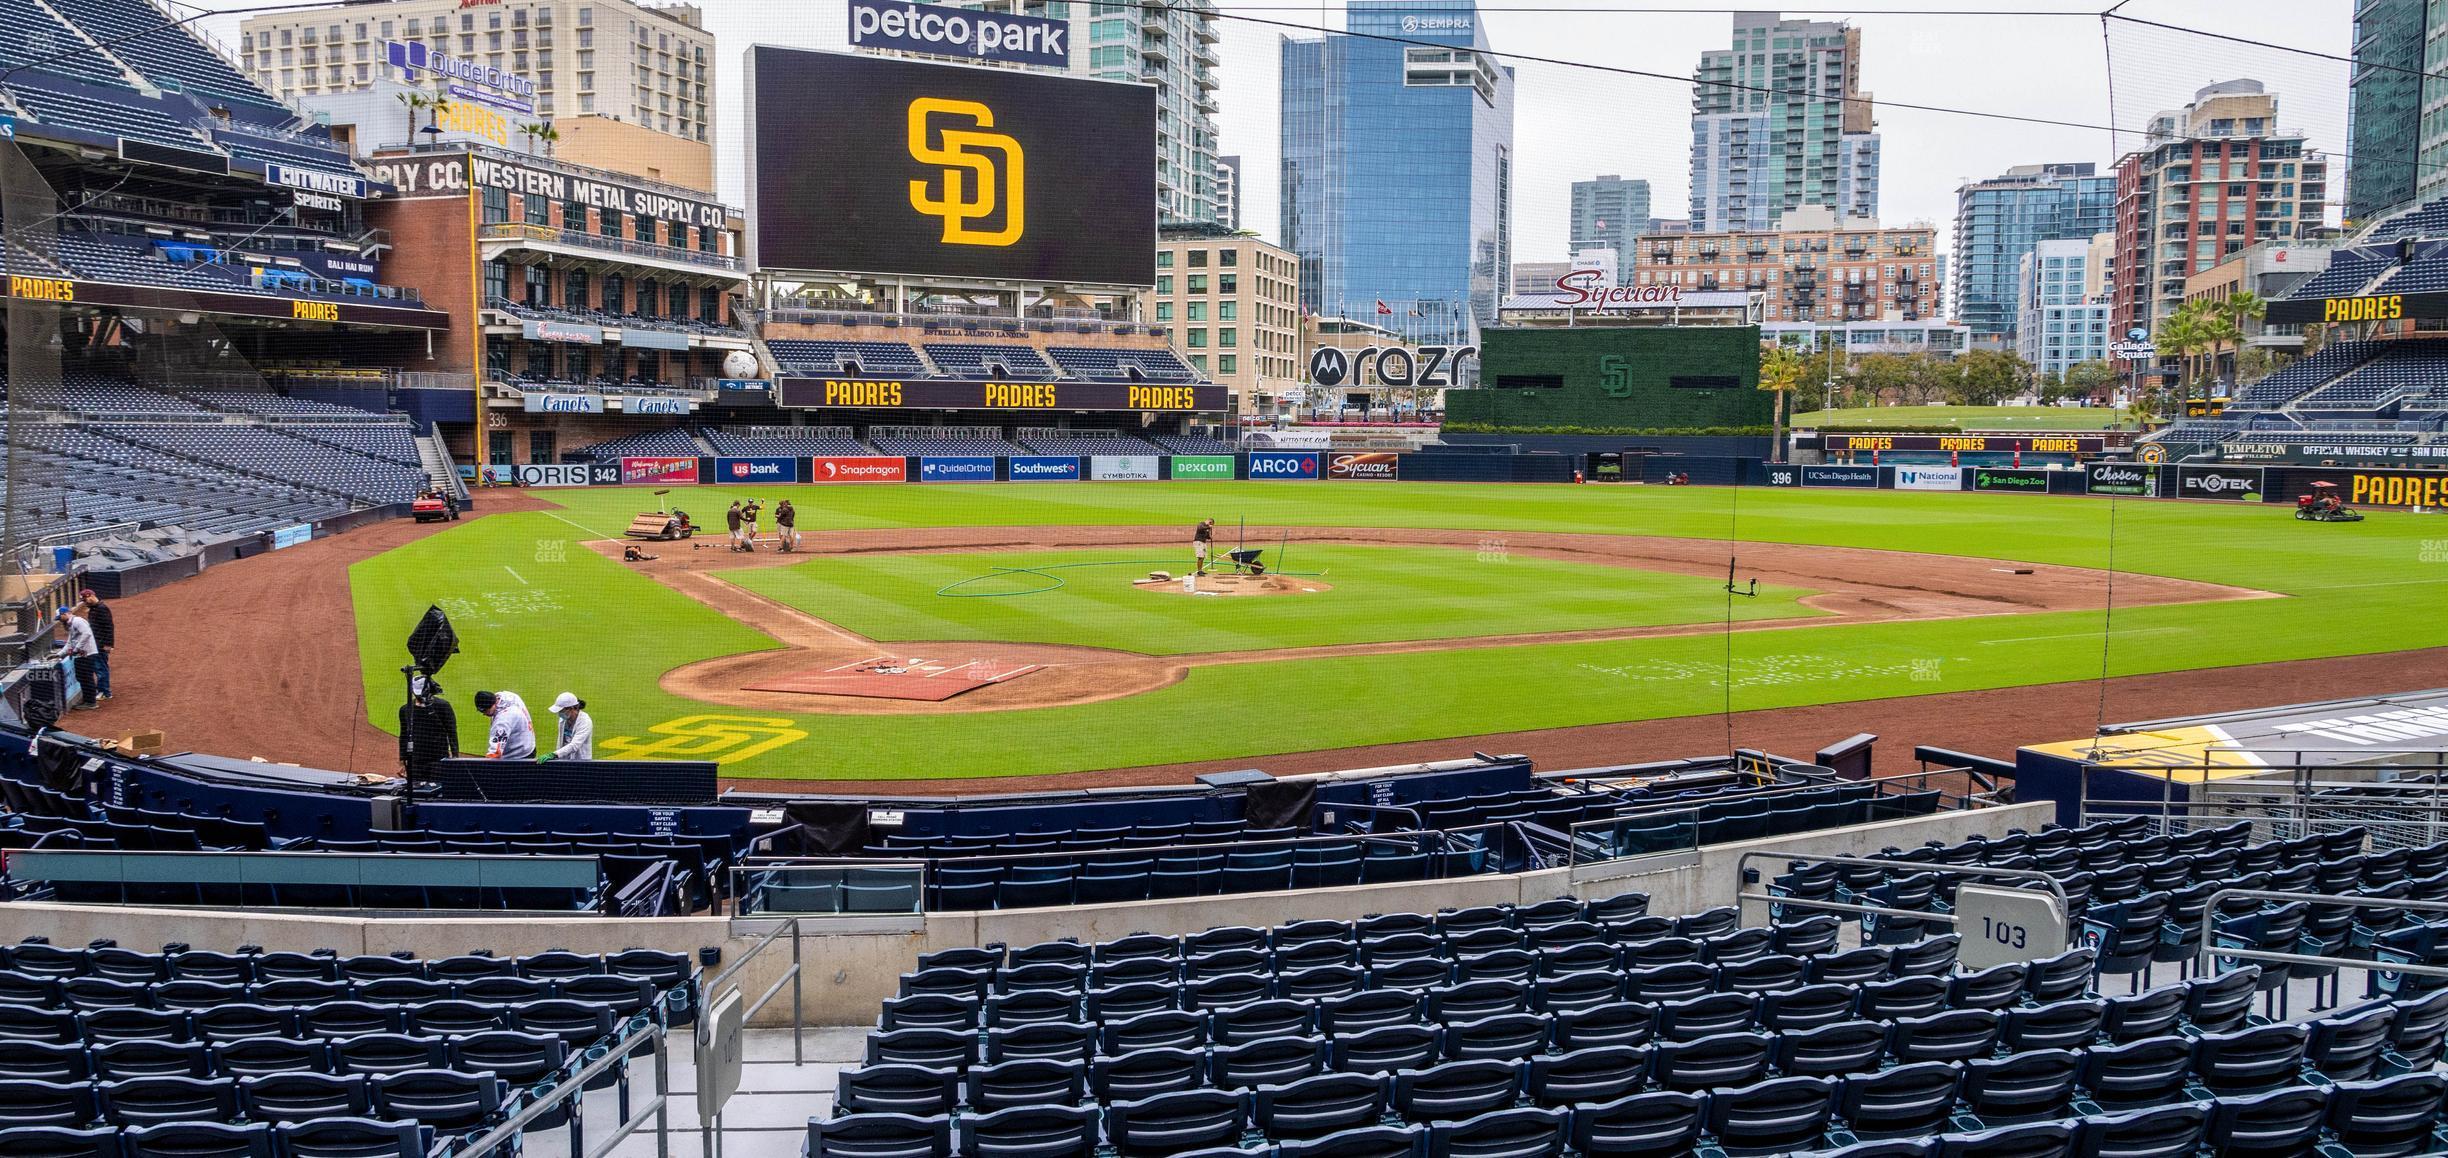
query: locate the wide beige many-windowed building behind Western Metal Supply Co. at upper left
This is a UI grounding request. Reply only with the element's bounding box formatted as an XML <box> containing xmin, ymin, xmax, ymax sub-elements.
<box><xmin>237</xmin><ymin>0</ymin><xmax>715</xmax><ymax>151</ymax></box>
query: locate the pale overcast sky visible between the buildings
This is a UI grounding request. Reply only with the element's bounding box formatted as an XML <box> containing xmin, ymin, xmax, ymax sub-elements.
<box><xmin>186</xmin><ymin>0</ymin><xmax>2353</xmax><ymax>260</ymax></box>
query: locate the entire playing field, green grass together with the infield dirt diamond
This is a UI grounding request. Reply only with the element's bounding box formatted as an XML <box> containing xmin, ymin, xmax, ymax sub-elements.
<box><xmin>263</xmin><ymin>482</ymin><xmax>2448</xmax><ymax>781</ymax></box>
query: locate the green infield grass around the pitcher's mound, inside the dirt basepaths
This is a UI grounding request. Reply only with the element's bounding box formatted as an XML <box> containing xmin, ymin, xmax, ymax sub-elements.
<box><xmin>725</xmin><ymin>541</ymin><xmax>1814</xmax><ymax>656</ymax></box>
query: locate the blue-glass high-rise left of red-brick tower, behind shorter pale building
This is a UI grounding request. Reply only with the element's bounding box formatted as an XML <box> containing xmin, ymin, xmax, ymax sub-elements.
<box><xmin>1951</xmin><ymin>162</ymin><xmax>2118</xmax><ymax>350</ymax></box>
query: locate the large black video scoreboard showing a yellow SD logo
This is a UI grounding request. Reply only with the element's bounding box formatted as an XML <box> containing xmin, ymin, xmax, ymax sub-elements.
<box><xmin>747</xmin><ymin>47</ymin><xmax>1155</xmax><ymax>286</ymax></box>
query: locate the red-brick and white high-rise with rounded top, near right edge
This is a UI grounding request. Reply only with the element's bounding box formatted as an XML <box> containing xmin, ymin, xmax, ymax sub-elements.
<box><xmin>2113</xmin><ymin>81</ymin><xmax>2328</xmax><ymax>333</ymax></box>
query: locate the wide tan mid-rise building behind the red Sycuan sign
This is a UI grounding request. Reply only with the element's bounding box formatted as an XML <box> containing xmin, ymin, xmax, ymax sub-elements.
<box><xmin>1630</xmin><ymin>206</ymin><xmax>1939</xmax><ymax>323</ymax></box>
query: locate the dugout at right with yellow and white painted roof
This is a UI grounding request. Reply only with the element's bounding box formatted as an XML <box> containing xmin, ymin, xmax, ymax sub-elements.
<box><xmin>2015</xmin><ymin>688</ymin><xmax>2448</xmax><ymax>835</ymax></box>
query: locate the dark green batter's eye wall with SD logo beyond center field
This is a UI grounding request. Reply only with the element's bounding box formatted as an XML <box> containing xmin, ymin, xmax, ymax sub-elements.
<box><xmin>1444</xmin><ymin>326</ymin><xmax>1777</xmax><ymax>433</ymax></box>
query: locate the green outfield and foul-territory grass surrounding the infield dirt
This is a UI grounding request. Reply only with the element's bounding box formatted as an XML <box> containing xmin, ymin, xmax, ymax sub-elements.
<box><xmin>350</xmin><ymin>482</ymin><xmax>2448</xmax><ymax>779</ymax></box>
